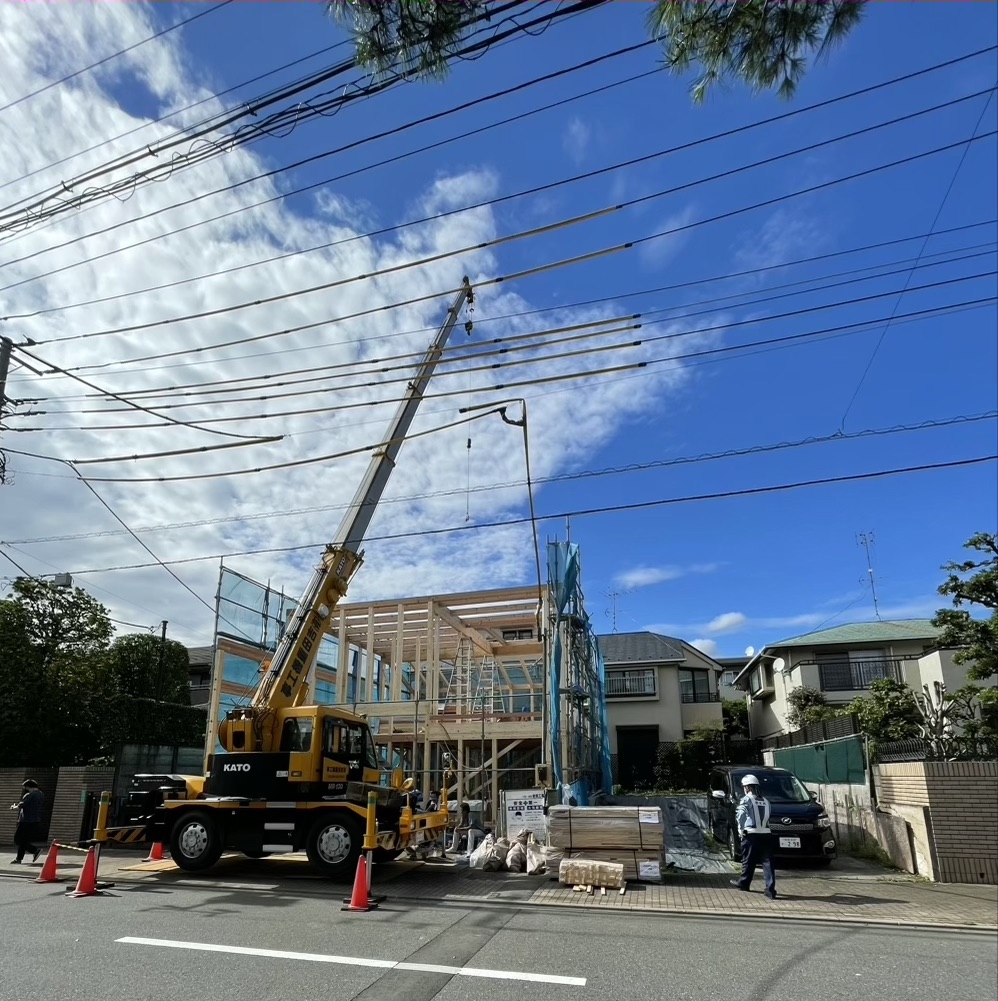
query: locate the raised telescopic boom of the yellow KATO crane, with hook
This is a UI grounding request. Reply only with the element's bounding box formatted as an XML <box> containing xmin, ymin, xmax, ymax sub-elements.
<box><xmin>230</xmin><ymin>276</ymin><xmax>474</xmax><ymax>751</ymax></box>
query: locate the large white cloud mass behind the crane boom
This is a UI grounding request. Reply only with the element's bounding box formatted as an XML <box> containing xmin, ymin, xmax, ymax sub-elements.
<box><xmin>0</xmin><ymin>4</ymin><xmax>689</xmax><ymax>643</ymax></box>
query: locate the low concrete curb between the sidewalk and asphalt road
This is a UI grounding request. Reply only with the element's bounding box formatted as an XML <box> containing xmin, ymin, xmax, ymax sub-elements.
<box><xmin>0</xmin><ymin>871</ymin><xmax>998</xmax><ymax>938</ymax></box>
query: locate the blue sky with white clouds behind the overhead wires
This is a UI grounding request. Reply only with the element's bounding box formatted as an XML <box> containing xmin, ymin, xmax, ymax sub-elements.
<box><xmin>0</xmin><ymin>3</ymin><xmax>998</xmax><ymax>656</ymax></box>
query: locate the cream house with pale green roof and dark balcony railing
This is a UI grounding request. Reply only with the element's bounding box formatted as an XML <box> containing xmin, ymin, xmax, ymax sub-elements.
<box><xmin>735</xmin><ymin>619</ymin><xmax>967</xmax><ymax>738</ymax></box>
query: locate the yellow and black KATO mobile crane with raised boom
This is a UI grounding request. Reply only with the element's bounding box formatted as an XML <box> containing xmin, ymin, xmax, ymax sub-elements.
<box><xmin>93</xmin><ymin>276</ymin><xmax>474</xmax><ymax>877</ymax></box>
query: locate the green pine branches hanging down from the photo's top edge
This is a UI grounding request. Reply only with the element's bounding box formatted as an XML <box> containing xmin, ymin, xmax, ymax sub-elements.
<box><xmin>327</xmin><ymin>0</ymin><xmax>865</xmax><ymax>103</ymax></box>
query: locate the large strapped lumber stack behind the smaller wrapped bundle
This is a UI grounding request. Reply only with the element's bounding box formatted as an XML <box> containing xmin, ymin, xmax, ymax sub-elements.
<box><xmin>548</xmin><ymin>806</ymin><xmax>665</xmax><ymax>882</ymax></box>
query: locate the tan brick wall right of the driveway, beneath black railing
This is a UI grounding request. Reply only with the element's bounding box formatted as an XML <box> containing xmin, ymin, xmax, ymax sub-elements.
<box><xmin>876</xmin><ymin>761</ymin><xmax>998</xmax><ymax>885</ymax></box>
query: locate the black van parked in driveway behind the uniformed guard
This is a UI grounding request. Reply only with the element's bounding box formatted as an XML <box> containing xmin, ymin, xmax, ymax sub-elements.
<box><xmin>708</xmin><ymin>765</ymin><xmax>836</xmax><ymax>865</ymax></box>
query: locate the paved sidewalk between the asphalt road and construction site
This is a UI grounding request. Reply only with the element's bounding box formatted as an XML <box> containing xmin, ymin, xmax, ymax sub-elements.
<box><xmin>0</xmin><ymin>851</ymin><xmax>998</xmax><ymax>930</ymax></box>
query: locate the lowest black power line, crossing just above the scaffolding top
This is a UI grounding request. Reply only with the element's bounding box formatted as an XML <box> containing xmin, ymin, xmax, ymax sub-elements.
<box><xmin>60</xmin><ymin>454</ymin><xmax>998</xmax><ymax>577</ymax></box>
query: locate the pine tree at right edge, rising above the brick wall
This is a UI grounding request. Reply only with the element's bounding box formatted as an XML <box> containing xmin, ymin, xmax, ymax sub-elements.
<box><xmin>932</xmin><ymin>532</ymin><xmax>998</xmax><ymax>681</ymax></box>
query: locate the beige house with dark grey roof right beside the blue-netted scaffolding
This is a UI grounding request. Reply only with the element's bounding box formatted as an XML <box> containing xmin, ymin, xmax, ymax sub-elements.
<box><xmin>598</xmin><ymin>633</ymin><xmax>723</xmax><ymax>788</ymax></box>
